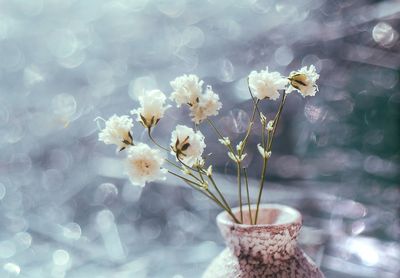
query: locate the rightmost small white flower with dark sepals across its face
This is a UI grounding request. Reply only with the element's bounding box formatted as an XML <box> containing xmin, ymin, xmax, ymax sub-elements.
<box><xmin>287</xmin><ymin>65</ymin><xmax>319</xmax><ymax>97</ymax></box>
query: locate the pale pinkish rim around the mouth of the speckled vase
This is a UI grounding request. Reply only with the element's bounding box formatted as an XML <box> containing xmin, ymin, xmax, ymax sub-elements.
<box><xmin>217</xmin><ymin>203</ymin><xmax>302</xmax><ymax>228</ymax></box>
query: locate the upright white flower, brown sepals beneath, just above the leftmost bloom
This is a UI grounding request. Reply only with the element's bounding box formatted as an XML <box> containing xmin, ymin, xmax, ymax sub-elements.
<box><xmin>131</xmin><ymin>90</ymin><xmax>171</xmax><ymax>128</ymax></box>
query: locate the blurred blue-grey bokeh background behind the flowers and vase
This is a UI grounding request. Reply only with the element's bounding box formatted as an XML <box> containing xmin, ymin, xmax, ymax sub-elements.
<box><xmin>0</xmin><ymin>0</ymin><xmax>400</xmax><ymax>278</ymax></box>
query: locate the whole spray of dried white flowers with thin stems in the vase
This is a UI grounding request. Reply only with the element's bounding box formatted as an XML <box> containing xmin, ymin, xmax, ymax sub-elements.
<box><xmin>99</xmin><ymin>65</ymin><xmax>319</xmax><ymax>225</ymax></box>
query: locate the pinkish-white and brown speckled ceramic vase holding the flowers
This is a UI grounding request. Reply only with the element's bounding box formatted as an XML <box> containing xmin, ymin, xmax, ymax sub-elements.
<box><xmin>203</xmin><ymin>204</ymin><xmax>324</xmax><ymax>278</ymax></box>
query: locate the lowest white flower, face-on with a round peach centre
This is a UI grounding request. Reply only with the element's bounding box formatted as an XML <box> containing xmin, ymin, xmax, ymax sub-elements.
<box><xmin>125</xmin><ymin>143</ymin><xmax>167</xmax><ymax>186</ymax></box>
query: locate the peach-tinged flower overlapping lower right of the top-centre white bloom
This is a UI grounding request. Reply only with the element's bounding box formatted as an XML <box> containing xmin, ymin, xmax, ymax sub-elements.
<box><xmin>190</xmin><ymin>86</ymin><xmax>222</xmax><ymax>124</ymax></box>
